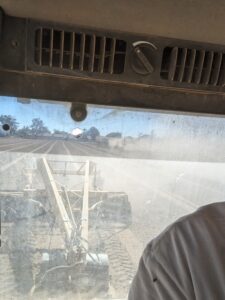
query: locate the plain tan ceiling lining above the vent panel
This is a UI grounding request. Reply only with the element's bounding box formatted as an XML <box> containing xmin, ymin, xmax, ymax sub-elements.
<box><xmin>0</xmin><ymin>0</ymin><xmax>225</xmax><ymax>44</ymax></box>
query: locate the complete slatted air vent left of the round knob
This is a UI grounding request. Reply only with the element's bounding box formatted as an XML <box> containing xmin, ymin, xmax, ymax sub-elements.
<box><xmin>34</xmin><ymin>28</ymin><xmax>126</xmax><ymax>74</ymax></box>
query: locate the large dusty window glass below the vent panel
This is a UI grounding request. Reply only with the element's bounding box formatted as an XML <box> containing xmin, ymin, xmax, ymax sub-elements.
<box><xmin>0</xmin><ymin>97</ymin><xmax>225</xmax><ymax>299</ymax></box>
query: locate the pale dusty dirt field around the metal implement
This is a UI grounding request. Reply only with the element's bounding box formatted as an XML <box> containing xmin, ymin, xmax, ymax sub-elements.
<box><xmin>0</xmin><ymin>139</ymin><xmax>225</xmax><ymax>299</ymax></box>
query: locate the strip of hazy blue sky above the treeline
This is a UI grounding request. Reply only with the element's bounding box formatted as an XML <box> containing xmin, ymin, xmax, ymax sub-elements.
<box><xmin>0</xmin><ymin>97</ymin><xmax>225</xmax><ymax>137</ymax></box>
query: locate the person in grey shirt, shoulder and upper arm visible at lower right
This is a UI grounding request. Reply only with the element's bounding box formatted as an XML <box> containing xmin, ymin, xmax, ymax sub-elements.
<box><xmin>128</xmin><ymin>202</ymin><xmax>225</xmax><ymax>300</ymax></box>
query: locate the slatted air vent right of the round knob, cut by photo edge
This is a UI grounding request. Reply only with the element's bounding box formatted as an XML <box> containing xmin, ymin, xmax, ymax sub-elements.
<box><xmin>161</xmin><ymin>47</ymin><xmax>225</xmax><ymax>86</ymax></box>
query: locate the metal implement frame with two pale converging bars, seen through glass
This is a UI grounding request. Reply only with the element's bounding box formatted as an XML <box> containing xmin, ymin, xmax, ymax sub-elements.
<box><xmin>0</xmin><ymin>157</ymin><xmax>131</xmax><ymax>294</ymax></box>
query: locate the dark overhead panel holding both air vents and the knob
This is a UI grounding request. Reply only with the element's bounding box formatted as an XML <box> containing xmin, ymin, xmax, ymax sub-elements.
<box><xmin>0</xmin><ymin>9</ymin><xmax>225</xmax><ymax>113</ymax></box>
